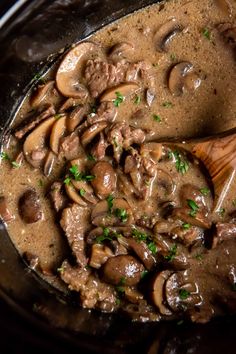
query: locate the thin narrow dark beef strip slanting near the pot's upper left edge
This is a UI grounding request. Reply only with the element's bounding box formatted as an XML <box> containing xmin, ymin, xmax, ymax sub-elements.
<box><xmin>14</xmin><ymin>104</ymin><xmax>56</xmax><ymax>139</ymax></box>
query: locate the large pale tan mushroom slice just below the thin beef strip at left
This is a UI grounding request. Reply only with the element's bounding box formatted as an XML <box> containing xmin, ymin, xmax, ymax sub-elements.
<box><xmin>23</xmin><ymin>117</ymin><xmax>55</xmax><ymax>168</ymax></box>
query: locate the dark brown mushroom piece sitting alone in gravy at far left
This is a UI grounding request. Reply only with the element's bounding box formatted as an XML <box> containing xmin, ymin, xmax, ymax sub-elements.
<box><xmin>19</xmin><ymin>189</ymin><xmax>43</xmax><ymax>224</ymax></box>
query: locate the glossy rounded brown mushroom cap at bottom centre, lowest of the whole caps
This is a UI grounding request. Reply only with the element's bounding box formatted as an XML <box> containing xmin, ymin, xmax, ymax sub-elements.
<box><xmin>102</xmin><ymin>255</ymin><xmax>144</xmax><ymax>286</ymax></box>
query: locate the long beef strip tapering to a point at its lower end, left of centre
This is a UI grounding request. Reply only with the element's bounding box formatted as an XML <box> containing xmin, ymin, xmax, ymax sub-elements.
<box><xmin>60</xmin><ymin>204</ymin><xmax>90</xmax><ymax>267</ymax></box>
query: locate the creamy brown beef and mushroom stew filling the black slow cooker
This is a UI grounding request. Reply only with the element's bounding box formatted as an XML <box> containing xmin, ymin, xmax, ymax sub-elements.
<box><xmin>0</xmin><ymin>0</ymin><xmax>236</xmax><ymax>323</ymax></box>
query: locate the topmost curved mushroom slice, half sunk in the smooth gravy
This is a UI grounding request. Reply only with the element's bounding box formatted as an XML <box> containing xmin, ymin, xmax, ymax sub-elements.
<box><xmin>154</xmin><ymin>18</ymin><xmax>183</xmax><ymax>52</ymax></box>
